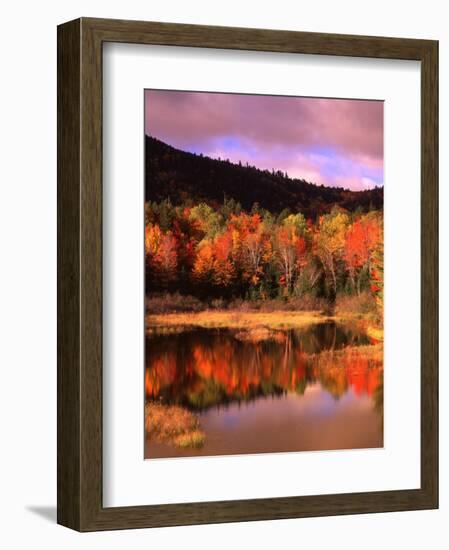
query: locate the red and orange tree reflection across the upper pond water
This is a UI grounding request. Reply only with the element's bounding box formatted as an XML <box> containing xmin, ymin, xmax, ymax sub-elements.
<box><xmin>145</xmin><ymin>323</ymin><xmax>383</xmax><ymax>411</ymax></box>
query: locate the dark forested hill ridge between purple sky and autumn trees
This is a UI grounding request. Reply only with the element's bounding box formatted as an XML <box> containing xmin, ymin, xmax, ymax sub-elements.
<box><xmin>145</xmin><ymin>136</ymin><xmax>383</xmax><ymax>217</ymax></box>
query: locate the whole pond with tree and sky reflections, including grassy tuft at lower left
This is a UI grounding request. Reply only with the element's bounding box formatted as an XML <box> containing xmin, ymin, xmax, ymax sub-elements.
<box><xmin>145</xmin><ymin>322</ymin><xmax>383</xmax><ymax>458</ymax></box>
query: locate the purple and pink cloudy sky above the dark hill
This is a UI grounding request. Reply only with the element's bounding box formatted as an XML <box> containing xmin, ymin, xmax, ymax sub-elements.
<box><xmin>145</xmin><ymin>90</ymin><xmax>383</xmax><ymax>190</ymax></box>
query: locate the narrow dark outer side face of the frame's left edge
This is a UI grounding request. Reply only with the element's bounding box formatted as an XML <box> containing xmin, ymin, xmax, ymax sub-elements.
<box><xmin>57</xmin><ymin>21</ymin><xmax>81</xmax><ymax>529</ymax></box>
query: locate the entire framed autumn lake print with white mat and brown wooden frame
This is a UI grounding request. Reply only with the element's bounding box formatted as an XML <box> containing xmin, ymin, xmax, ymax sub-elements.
<box><xmin>58</xmin><ymin>18</ymin><xmax>438</xmax><ymax>531</ymax></box>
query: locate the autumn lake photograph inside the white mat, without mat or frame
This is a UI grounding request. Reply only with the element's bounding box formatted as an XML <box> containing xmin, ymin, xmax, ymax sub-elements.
<box><xmin>144</xmin><ymin>90</ymin><xmax>384</xmax><ymax>459</ymax></box>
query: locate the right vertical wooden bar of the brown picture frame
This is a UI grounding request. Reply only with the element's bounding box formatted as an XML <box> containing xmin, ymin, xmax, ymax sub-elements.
<box><xmin>421</xmin><ymin>42</ymin><xmax>438</xmax><ymax>506</ymax></box>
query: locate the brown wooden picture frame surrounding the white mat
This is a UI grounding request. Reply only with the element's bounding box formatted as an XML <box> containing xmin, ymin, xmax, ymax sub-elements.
<box><xmin>58</xmin><ymin>18</ymin><xmax>438</xmax><ymax>531</ymax></box>
